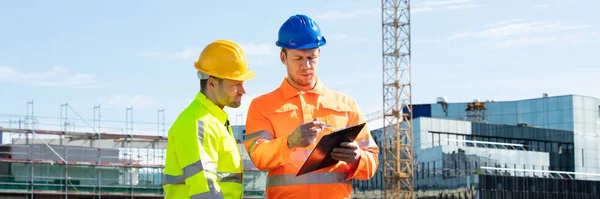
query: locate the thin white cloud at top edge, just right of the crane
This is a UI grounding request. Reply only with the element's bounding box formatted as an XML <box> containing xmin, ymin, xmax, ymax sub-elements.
<box><xmin>411</xmin><ymin>0</ymin><xmax>480</xmax><ymax>14</ymax></box>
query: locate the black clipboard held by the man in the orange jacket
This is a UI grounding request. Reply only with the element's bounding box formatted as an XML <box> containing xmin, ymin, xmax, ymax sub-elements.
<box><xmin>296</xmin><ymin>123</ymin><xmax>367</xmax><ymax>176</ymax></box>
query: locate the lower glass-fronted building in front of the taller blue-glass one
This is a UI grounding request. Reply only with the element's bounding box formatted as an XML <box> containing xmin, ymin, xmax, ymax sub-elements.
<box><xmin>413</xmin><ymin>117</ymin><xmax>600</xmax><ymax>198</ymax></box>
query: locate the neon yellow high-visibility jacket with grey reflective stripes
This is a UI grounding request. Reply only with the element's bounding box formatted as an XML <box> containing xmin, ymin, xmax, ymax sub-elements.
<box><xmin>163</xmin><ymin>92</ymin><xmax>244</xmax><ymax>199</ymax></box>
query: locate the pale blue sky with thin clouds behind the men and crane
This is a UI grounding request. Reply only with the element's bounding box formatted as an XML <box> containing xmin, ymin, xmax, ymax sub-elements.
<box><xmin>0</xmin><ymin>0</ymin><xmax>600</xmax><ymax>135</ymax></box>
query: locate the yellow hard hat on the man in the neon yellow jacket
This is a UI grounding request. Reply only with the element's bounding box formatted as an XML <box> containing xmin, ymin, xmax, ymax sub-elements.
<box><xmin>194</xmin><ymin>40</ymin><xmax>256</xmax><ymax>81</ymax></box>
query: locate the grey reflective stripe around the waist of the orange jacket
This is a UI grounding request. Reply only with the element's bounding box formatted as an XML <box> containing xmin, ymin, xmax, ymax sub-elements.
<box><xmin>267</xmin><ymin>172</ymin><xmax>352</xmax><ymax>187</ymax></box>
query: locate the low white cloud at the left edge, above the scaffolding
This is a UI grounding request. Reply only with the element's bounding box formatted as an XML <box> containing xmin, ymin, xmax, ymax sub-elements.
<box><xmin>0</xmin><ymin>66</ymin><xmax>110</xmax><ymax>88</ymax></box>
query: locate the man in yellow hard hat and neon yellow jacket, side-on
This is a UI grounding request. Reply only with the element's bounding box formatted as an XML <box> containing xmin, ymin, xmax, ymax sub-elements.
<box><xmin>163</xmin><ymin>40</ymin><xmax>256</xmax><ymax>199</ymax></box>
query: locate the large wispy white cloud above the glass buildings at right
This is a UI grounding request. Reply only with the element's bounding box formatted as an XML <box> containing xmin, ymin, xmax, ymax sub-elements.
<box><xmin>445</xmin><ymin>19</ymin><xmax>592</xmax><ymax>48</ymax></box>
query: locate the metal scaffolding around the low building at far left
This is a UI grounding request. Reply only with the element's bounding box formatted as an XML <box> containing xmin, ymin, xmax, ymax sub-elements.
<box><xmin>0</xmin><ymin>101</ymin><xmax>167</xmax><ymax>198</ymax></box>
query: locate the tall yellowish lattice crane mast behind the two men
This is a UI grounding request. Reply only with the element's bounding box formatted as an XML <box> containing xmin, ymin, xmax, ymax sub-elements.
<box><xmin>381</xmin><ymin>0</ymin><xmax>414</xmax><ymax>199</ymax></box>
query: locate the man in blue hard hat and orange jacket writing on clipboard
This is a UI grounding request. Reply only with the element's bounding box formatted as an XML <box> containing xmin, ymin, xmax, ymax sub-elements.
<box><xmin>244</xmin><ymin>15</ymin><xmax>379</xmax><ymax>199</ymax></box>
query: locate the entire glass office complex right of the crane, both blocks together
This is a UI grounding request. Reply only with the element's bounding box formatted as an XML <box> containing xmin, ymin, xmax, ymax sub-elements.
<box><xmin>404</xmin><ymin>95</ymin><xmax>600</xmax><ymax>198</ymax></box>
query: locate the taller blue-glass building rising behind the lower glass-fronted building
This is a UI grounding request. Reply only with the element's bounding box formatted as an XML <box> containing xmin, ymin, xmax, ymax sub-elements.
<box><xmin>422</xmin><ymin>95</ymin><xmax>600</xmax><ymax>177</ymax></box>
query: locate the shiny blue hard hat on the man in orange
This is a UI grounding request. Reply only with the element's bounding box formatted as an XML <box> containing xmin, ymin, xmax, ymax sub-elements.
<box><xmin>275</xmin><ymin>14</ymin><xmax>327</xmax><ymax>49</ymax></box>
